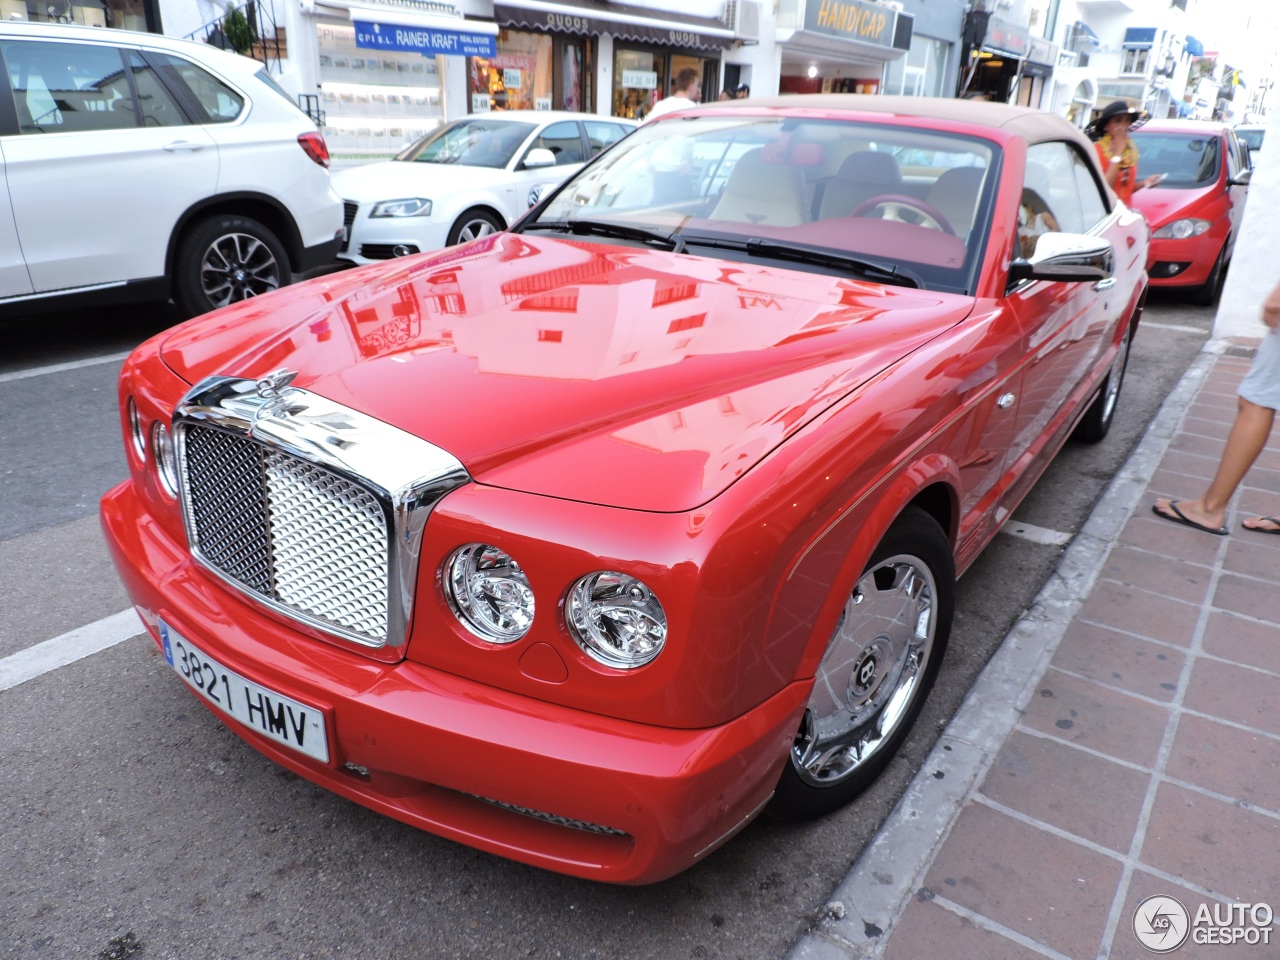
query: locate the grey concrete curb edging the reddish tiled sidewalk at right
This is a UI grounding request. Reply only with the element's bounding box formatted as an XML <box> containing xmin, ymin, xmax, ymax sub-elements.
<box><xmin>787</xmin><ymin>340</ymin><xmax>1230</xmax><ymax>960</ymax></box>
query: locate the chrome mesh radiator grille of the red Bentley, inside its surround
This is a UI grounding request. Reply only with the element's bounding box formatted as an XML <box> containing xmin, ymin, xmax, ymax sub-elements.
<box><xmin>179</xmin><ymin>424</ymin><xmax>390</xmax><ymax>645</ymax></box>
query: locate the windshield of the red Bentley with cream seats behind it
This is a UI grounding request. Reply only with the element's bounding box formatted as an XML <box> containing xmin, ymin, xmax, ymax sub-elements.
<box><xmin>517</xmin><ymin>111</ymin><xmax>996</xmax><ymax>291</ymax></box>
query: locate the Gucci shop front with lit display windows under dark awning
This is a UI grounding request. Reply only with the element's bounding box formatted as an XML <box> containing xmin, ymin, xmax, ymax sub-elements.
<box><xmin>483</xmin><ymin>0</ymin><xmax>735</xmax><ymax>119</ymax></box>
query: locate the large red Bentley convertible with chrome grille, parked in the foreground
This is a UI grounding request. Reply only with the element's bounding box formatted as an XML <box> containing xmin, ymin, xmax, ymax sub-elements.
<box><xmin>102</xmin><ymin>96</ymin><xmax>1148</xmax><ymax>883</ymax></box>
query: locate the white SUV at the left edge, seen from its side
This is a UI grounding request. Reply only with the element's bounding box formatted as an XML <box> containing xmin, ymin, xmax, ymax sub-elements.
<box><xmin>0</xmin><ymin>22</ymin><xmax>342</xmax><ymax>317</ymax></box>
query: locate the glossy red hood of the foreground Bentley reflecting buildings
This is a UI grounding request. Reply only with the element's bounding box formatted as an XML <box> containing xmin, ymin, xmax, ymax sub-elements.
<box><xmin>161</xmin><ymin>234</ymin><xmax>973</xmax><ymax>511</ymax></box>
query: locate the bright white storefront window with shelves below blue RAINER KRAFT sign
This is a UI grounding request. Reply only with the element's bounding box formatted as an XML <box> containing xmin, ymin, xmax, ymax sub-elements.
<box><xmin>316</xmin><ymin>23</ymin><xmax>444</xmax><ymax>159</ymax></box>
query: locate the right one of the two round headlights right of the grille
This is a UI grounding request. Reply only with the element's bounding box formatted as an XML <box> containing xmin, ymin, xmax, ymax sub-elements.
<box><xmin>564</xmin><ymin>571</ymin><xmax>667</xmax><ymax>669</ymax></box>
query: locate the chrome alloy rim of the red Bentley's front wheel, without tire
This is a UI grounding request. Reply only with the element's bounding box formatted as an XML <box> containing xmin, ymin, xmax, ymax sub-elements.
<box><xmin>791</xmin><ymin>554</ymin><xmax>937</xmax><ymax>787</ymax></box>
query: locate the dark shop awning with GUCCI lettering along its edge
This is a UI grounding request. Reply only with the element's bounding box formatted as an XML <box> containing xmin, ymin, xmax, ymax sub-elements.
<box><xmin>493</xmin><ymin>0</ymin><xmax>735</xmax><ymax>50</ymax></box>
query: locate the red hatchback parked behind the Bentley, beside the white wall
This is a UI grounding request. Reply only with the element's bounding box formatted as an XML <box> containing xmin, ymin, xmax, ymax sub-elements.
<box><xmin>1130</xmin><ymin>120</ymin><xmax>1252</xmax><ymax>306</ymax></box>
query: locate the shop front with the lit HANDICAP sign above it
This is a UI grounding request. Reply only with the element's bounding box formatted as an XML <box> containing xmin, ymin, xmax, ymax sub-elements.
<box><xmin>777</xmin><ymin>0</ymin><xmax>916</xmax><ymax>93</ymax></box>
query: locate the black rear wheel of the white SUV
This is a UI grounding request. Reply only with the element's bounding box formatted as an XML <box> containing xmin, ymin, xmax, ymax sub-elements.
<box><xmin>173</xmin><ymin>214</ymin><xmax>293</xmax><ymax>316</ymax></box>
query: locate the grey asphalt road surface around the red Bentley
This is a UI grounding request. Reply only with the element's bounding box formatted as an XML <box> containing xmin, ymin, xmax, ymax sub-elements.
<box><xmin>0</xmin><ymin>294</ymin><xmax>1213</xmax><ymax>960</ymax></box>
